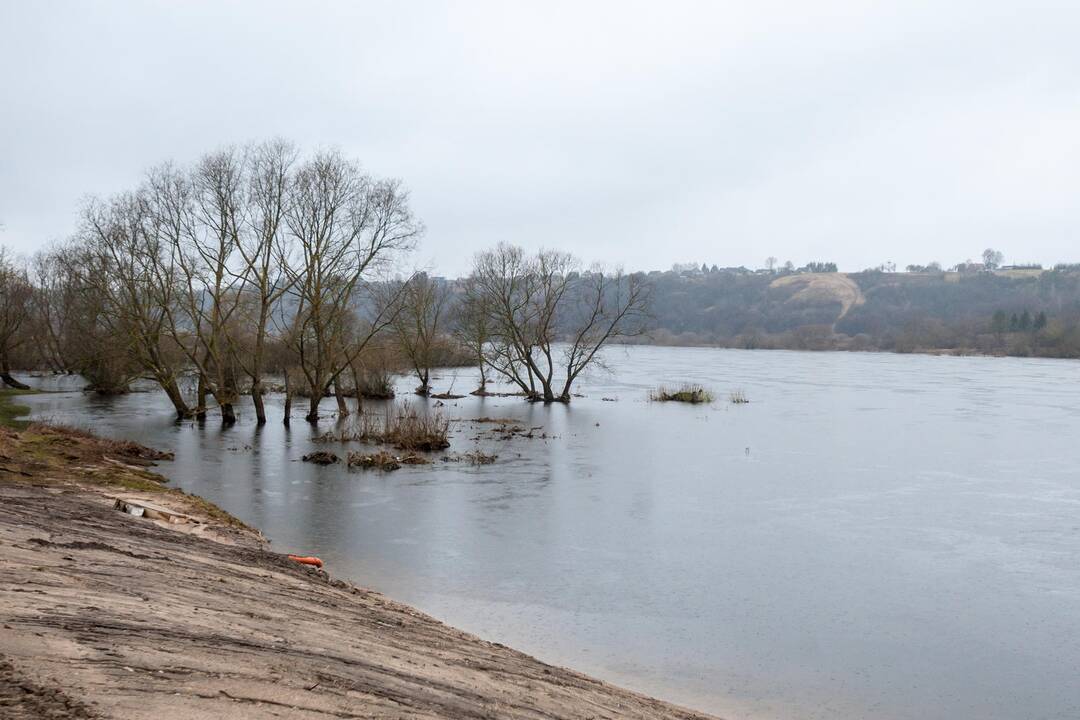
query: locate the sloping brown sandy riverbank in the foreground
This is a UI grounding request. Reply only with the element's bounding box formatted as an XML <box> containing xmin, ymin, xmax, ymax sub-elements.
<box><xmin>0</xmin><ymin>424</ymin><xmax>705</xmax><ymax>719</ymax></box>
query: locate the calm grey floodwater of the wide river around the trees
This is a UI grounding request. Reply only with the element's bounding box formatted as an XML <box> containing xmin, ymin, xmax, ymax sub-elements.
<box><xmin>19</xmin><ymin>347</ymin><xmax>1080</xmax><ymax>720</ymax></box>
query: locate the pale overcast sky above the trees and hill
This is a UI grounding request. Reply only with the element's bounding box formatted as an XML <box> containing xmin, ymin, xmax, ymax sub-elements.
<box><xmin>0</xmin><ymin>0</ymin><xmax>1080</xmax><ymax>275</ymax></box>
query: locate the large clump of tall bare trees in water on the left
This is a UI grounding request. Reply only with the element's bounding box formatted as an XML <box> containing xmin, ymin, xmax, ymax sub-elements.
<box><xmin>0</xmin><ymin>140</ymin><xmax>425</xmax><ymax>423</ymax></box>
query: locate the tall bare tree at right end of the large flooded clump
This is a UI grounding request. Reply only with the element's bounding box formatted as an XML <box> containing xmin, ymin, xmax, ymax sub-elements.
<box><xmin>285</xmin><ymin>151</ymin><xmax>421</xmax><ymax>422</ymax></box>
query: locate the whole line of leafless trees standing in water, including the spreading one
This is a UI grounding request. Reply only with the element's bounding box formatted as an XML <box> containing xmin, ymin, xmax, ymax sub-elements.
<box><xmin>0</xmin><ymin>140</ymin><xmax>648</xmax><ymax>423</ymax></box>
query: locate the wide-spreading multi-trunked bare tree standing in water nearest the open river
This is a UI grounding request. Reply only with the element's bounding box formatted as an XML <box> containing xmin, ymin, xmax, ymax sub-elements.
<box><xmin>472</xmin><ymin>240</ymin><xmax>648</xmax><ymax>403</ymax></box>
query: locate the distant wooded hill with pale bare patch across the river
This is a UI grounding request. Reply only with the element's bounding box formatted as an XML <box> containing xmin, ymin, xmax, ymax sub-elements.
<box><xmin>639</xmin><ymin>267</ymin><xmax>1080</xmax><ymax>357</ymax></box>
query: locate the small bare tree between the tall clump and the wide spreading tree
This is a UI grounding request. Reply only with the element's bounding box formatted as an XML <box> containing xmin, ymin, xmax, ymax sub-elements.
<box><xmin>391</xmin><ymin>273</ymin><xmax>449</xmax><ymax>396</ymax></box>
